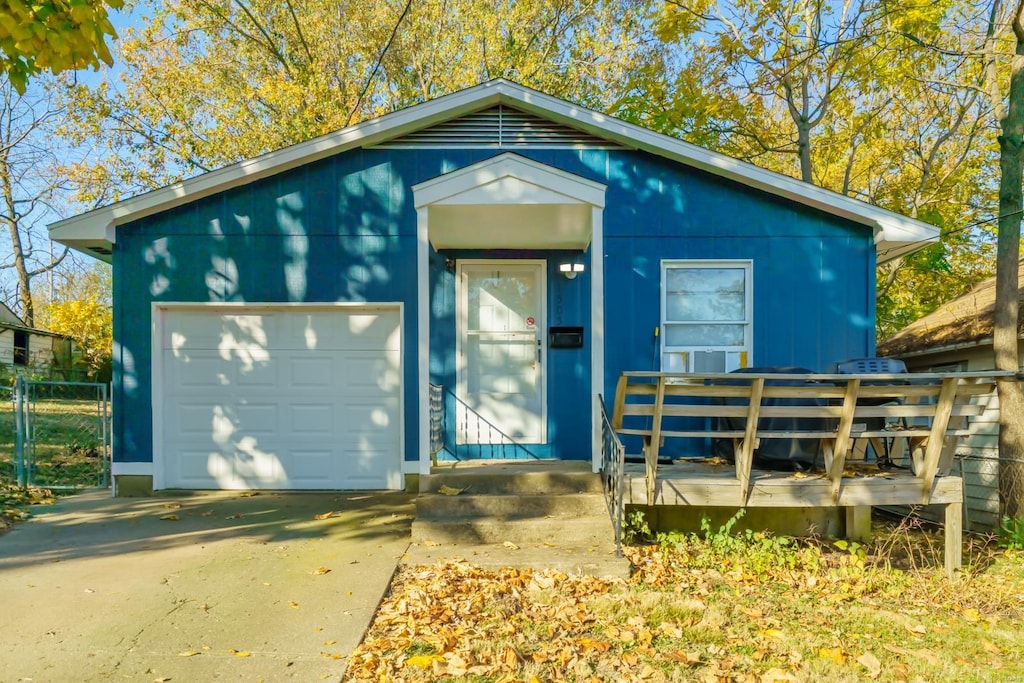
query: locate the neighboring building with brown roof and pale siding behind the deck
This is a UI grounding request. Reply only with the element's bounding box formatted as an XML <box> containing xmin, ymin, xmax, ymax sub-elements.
<box><xmin>878</xmin><ymin>261</ymin><xmax>1024</xmax><ymax>531</ymax></box>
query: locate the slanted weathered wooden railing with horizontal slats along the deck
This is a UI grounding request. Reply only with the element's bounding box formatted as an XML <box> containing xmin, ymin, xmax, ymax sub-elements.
<box><xmin>611</xmin><ymin>371</ymin><xmax>1013</xmax><ymax>505</ymax></box>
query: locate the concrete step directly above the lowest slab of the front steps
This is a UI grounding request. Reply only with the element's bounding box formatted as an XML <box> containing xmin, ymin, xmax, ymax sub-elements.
<box><xmin>413</xmin><ymin>514</ymin><xmax>614</xmax><ymax>546</ymax></box>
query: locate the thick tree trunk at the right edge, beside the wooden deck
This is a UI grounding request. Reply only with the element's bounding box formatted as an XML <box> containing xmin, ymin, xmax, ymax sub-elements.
<box><xmin>992</xmin><ymin>0</ymin><xmax>1024</xmax><ymax>519</ymax></box>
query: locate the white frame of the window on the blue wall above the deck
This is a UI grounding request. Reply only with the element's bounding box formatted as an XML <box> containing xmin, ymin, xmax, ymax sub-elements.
<box><xmin>658</xmin><ymin>259</ymin><xmax>754</xmax><ymax>373</ymax></box>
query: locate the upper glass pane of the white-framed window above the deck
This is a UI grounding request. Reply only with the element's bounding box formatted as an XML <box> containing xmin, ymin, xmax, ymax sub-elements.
<box><xmin>665</xmin><ymin>268</ymin><xmax>746</xmax><ymax>321</ymax></box>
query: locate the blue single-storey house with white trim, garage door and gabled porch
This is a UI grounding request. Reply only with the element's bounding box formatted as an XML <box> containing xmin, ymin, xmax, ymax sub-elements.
<box><xmin>50</xmin><ymin>80</ymin><xmax>938</xmax><ymax>497</ymax></box>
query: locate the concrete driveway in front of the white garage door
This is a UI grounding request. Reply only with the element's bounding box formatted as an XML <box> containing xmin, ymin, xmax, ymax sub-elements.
<box><xmin>0</xmin><ymin>492</ymin><xmax>414</xmax><ymax>682</ymax></box>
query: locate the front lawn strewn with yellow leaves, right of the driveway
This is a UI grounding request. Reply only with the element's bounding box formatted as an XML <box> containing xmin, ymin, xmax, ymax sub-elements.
<box><xmin>347</xmin><ymin>530</ymin><xmax>1024</xmax><ymax>683</ymax></box>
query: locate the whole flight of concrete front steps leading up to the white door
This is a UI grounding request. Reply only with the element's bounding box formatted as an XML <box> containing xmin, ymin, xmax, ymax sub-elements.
<box><xmin>402</xmin><ymin>461</ymin><xmax>630</xmax><ymax>578</ymax></box>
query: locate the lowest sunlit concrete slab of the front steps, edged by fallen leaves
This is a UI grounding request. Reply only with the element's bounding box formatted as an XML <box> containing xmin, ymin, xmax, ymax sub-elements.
<box><xmin>401</xmin><ymin>540</ymin><xmax>631</xmax><ymax>579</ymax></box>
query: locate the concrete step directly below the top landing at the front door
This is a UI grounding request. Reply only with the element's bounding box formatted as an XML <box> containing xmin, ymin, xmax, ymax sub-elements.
<box><xmin>416</xmin><ymin>489</ymin><xmax>608</xmax><ymax>520</ymax></box>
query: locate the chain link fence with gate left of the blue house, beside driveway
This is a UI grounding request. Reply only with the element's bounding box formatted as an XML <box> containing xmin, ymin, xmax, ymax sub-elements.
<box><xmin>0</xmin><ymin>379</ymin><xmax>111</xmax><ymax>488</ymax></box>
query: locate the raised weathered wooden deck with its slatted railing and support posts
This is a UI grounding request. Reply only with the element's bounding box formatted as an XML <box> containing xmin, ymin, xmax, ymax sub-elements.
<box><xmin>605</xmin><ymin>372</ymin><xmax>1013</xmax><ymax>574</ymax></box>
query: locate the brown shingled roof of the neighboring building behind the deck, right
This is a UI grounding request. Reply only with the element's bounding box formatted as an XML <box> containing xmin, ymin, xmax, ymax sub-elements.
<box><xmin>876</xmin><ymin>261</ymin><xmax>1024</xmax><ymax>356</ymax></box>
